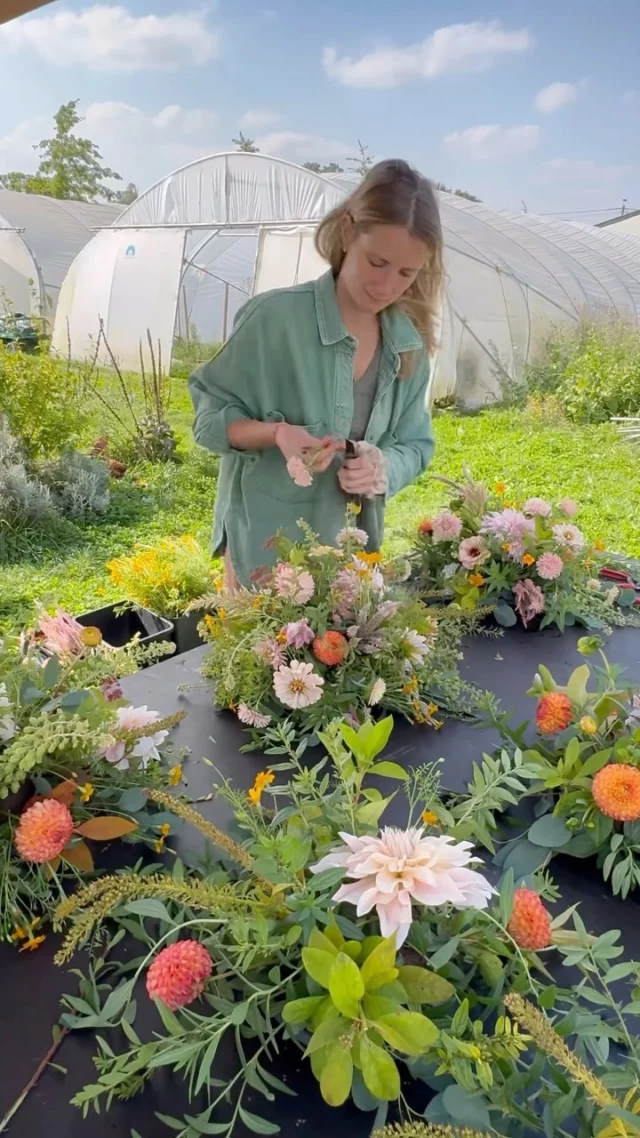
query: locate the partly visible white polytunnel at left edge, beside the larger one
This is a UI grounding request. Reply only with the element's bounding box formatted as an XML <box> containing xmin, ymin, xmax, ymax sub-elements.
<box><xmin>0</xmin><ymin>184</ymin><xmax>122</xmax><ymax>324</ymax></box>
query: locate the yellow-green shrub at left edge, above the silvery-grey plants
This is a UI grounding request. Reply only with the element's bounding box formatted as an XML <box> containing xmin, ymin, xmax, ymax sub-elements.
<box><xmin>0</xmin><ymin>347</ymin><xmax>87</xmax><ymax>459</ymax></box>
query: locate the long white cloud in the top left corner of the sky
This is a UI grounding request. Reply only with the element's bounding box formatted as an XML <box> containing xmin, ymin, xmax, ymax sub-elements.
<box><xmin>0</xmin><ymin>3</ymin><xmax>220</xmax><ymax>72</ymax></box>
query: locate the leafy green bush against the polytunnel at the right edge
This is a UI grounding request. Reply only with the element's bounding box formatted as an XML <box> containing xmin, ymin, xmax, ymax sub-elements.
<box><xmin>526</xmin><ymin>320</ymin><xmax>640</xmax><ymax>423</ymax></box>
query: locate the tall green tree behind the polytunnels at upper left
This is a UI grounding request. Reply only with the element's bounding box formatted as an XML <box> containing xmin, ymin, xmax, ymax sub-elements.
<box><xmin>0</xmin><ymin>99</ymin><xmax>122</xmax><ymax>201</ymax></box>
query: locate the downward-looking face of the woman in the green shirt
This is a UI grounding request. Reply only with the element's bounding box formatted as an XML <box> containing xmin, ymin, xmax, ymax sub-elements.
<box><xmin>339</xmin><ymin>217</ymin><xmax>429</xmax><ymax>313</ymax></box>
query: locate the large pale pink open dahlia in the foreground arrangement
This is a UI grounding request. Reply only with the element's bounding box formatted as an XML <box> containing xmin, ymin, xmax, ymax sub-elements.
<box><xmin>310</xmin><ymin>826</ymin><xmax>494</xmax><ymax>948</ymax></box>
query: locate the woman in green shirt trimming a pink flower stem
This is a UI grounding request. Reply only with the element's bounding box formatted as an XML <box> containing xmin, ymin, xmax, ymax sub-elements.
<box><xmin>189</xmin><ymin>160</ymin><xmax>442</xmax><ymax>587</ymax></box>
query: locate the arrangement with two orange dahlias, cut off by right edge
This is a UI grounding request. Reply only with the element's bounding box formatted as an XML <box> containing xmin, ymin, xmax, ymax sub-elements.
<box><xmin>482</xmin><ymin>636</ymin><xmax>640</xmax><ymax>897</ymax></box>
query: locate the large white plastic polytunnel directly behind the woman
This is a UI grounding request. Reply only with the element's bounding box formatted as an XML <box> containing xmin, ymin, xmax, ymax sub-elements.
<box><xmin>54</xmin><ymin>152</ymin><xmax>640</xmax><ymax>405</ymax></box>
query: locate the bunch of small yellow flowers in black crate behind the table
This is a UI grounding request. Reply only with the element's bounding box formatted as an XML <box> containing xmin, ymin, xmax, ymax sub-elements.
<box><xmin>107</xmin><ymin>535</ymin><xmax>218</xmax><ymax>618</ymax></box>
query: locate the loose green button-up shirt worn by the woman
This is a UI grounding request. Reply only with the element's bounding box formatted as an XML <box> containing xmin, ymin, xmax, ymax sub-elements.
<box><xmin>189</xmin><ymin>272</ymin><xmax>434</xmax><ymax>586</ymax></box>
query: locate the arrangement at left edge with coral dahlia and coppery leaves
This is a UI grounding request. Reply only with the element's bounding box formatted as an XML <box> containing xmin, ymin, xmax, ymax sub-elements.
<box><xmin>0</xmin><ymin>612</ymin><xmax>181</xmax><ymax>950</ymax></box>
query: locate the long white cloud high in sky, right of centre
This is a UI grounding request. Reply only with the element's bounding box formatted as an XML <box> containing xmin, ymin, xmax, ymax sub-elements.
<box><xmin>322</xmin><ymin>19</ymin><xmax>533</xmax><ymax>89</ymax></box>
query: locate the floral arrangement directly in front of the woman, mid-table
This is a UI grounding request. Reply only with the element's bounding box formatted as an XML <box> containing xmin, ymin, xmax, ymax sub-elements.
<box><xmin>198</xmin><ymin>506</ymin><xmax>487</xmax><ymax>741</ymax></box>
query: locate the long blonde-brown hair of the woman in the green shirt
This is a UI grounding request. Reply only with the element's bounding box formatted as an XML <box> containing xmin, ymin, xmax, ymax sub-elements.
<box><xmin>315</xmin><ymin>159</ymin><xmax>443</xmax><ymax>376</ymax></box>
